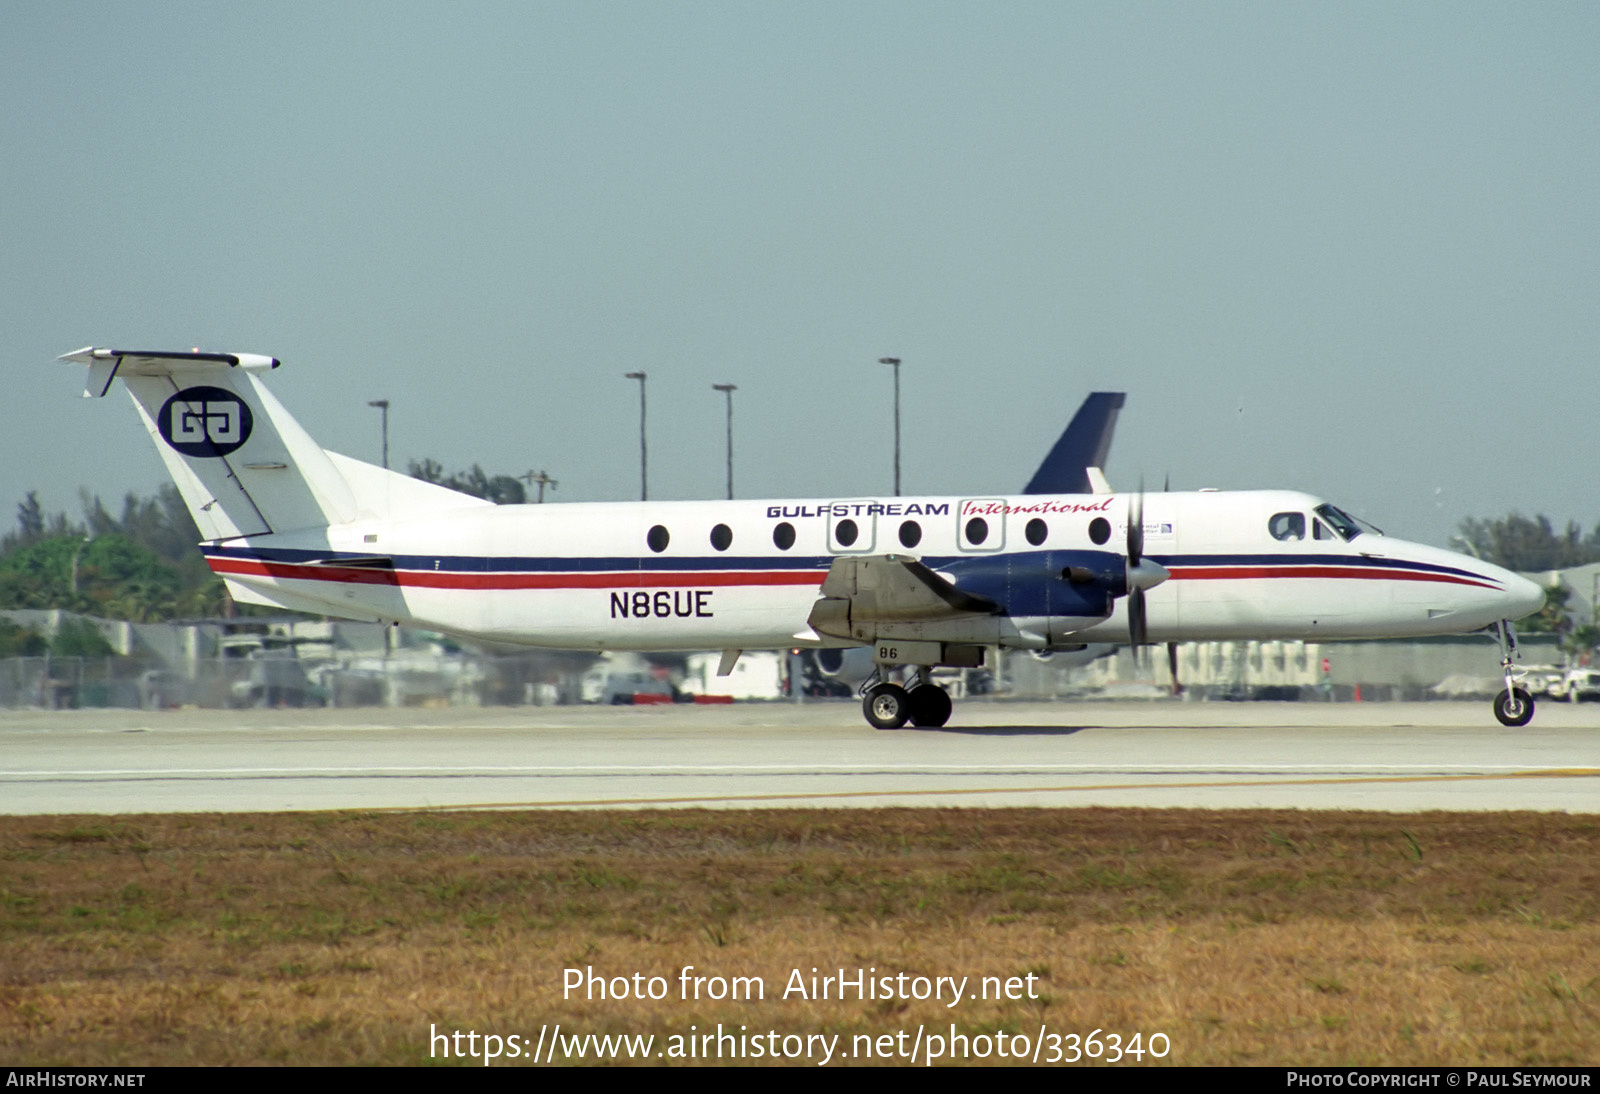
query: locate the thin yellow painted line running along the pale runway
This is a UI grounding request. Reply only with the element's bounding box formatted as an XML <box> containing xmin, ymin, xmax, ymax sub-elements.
<box><xmin>377</xmin><ymin>768</ymin><xmax>1600</xmax><ymax>813</ymax></box>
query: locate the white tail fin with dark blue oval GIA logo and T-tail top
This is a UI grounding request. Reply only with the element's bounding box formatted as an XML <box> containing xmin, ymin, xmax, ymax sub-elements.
<box><xmin>61</xmin><ymin>347</ymin><xmax>490</xmax><ymax>541</ymax></box>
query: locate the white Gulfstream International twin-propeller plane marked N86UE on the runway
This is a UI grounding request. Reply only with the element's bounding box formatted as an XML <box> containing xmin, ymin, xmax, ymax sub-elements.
<box><xmin>62</xmin><ymin>347</ymin><xmax>1544</xmax><ymax>729</ymax></box>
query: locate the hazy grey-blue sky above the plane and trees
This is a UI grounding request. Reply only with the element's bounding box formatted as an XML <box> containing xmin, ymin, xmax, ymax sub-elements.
<box><xmin>0</xmin><ymin>0</ymin><xmax>1600</xmax><ymax>542</ymax></box>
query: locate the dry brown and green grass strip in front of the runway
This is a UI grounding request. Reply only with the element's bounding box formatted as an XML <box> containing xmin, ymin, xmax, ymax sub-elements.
<box><xmin>0</xmin><ymin>809</ymin><xmax>1600</xmax><ymax>1065</ymax></box>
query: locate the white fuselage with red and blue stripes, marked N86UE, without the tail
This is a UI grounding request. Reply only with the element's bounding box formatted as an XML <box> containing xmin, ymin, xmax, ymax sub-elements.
<box><xmin>203</xmin><ymin>491</ymin><xmax>1542</xmax><ymax>651</ymax></box>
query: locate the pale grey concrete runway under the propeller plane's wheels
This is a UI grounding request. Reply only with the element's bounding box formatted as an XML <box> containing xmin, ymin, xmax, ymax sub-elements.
<box><xmin>0</xmin><ymin>701</ymin><xmax>1600</xmax><ymax>814</ymax></box>
